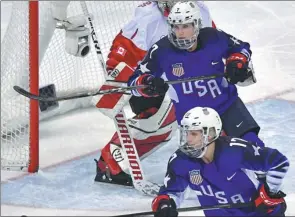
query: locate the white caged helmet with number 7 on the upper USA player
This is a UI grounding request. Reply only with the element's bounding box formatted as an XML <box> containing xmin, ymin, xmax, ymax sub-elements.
<box><xmin>168</xmin><ymin>1</ymin><xmax>202</xmax><ymax>50</ymax></box>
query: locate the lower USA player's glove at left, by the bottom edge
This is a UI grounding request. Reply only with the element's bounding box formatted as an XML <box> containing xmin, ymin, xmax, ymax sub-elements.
<box><xmin>152</xmin><ymin>195</ymin><xmax>178</xmax><ymax>217</ymax></box>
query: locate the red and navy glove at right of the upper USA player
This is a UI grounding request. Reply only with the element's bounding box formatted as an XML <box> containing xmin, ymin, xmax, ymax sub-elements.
<box><xmin>225</xmin><ymin>53</ymin><xmax>252</xmax><ymax>84</ymax></box>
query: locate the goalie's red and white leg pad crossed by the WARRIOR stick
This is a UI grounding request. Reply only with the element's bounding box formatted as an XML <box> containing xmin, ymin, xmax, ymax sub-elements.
<box><xmin>101</xmin><ymin>101</ymin><xmax>177</xmax><ymax>174</ymax></box>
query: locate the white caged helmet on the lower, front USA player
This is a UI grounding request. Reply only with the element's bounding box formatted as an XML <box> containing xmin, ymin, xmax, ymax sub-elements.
<box><xmin>179</xmin><ymin>107</ymin><xmax>222</xmax><ymax>158</ymax></box>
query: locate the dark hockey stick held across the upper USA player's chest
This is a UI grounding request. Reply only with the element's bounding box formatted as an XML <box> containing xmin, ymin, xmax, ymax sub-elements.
<box><xmin>13</xmin><ymin>73</ymin><xmax>224</xmax><ymax>102</ymax></box>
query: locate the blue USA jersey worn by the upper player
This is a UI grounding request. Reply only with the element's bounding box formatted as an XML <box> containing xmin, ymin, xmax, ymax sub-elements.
<box><xmin>128</xmin><ymin>27</ymin><xmax>251</xmax><ymax>122</ymax></box>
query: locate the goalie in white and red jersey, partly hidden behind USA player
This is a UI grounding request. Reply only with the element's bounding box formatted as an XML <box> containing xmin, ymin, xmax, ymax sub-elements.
<box><xmin>95</xmin><ymin>1</ymin><xmax>215</xmax><ymax>185</ymax></box>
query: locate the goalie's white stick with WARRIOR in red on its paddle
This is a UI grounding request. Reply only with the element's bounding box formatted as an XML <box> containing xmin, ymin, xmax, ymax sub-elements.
<box><xmin>80</xmin><ymin>1</ymin><xmax>160</xmax><ymax>196</ymax></box>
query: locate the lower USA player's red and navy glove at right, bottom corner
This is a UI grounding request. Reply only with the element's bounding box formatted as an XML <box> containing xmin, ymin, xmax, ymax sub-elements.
<box><xmin>254</xmin><ymin>184</ymin><xmax>287</xmax><ymax>216</ymax></box>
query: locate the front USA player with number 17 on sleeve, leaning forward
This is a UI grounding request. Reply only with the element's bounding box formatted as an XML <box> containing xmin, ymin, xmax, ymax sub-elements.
<box><xmin>152</xmin><ymin>107</ymin><xmax>289</xmax><ymax>217</ymax></box>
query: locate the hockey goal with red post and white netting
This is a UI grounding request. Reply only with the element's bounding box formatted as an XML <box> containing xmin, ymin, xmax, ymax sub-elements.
<box><xmin>1</xmin><ymin>0</ymin><xmax>142</xmax><ymax>172</ymax></box>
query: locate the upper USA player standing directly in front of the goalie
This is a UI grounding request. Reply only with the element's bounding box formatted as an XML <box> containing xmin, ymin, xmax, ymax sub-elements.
<box><xmin>129</xmin><ymin>1</ymin><xmax>264</xmax><ymax>150</ymax></box>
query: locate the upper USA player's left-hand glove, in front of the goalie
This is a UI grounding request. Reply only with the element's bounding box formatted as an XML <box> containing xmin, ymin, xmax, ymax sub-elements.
<box><xmin>136</xmin><ymin>74</ymin><xmax>169</xmax><ymax>97</ymax></box>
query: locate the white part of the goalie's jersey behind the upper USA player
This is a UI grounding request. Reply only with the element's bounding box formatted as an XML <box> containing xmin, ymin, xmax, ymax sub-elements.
<box><xmin>122</xmin><ymin>1</ymin><xmax>213</xmax><ymax>51</ymax></box>
